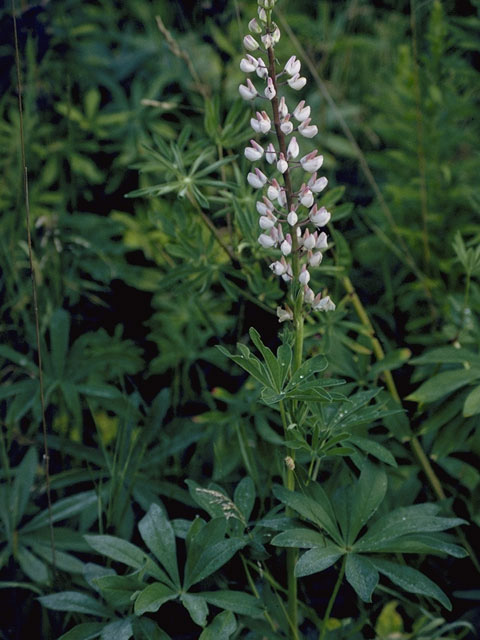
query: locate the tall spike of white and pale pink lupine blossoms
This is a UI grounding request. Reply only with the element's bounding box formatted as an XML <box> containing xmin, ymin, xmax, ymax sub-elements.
<box><xmin>239</xmin><ymin>0</ymin><xmax>335</xmax><ymax>322</ymax></box>
